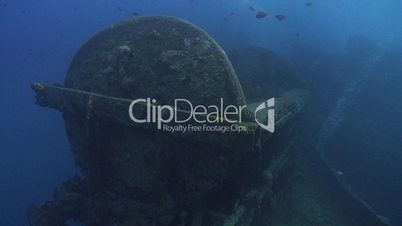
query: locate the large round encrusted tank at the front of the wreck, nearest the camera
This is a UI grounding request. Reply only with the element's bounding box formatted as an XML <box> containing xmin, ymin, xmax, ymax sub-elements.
<box><xmin>31</xmin><ymin>16</ymin><xmax>251</xmax><ymax>225</ymax></box>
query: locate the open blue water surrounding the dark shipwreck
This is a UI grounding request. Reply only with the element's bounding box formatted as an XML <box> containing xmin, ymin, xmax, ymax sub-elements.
<box><xmin>0</xmin><ymin>0</ymin><xmax>402</xmax><ymax>226</ymax></box>
